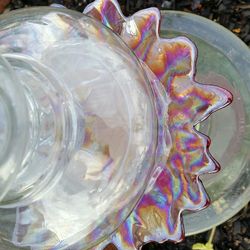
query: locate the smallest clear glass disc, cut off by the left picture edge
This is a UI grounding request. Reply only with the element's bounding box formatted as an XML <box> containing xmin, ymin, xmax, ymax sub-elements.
<box><xmin>0</xmin><ymin>56</ymin><xmax>28</xmax><ymax>202</ymax></box>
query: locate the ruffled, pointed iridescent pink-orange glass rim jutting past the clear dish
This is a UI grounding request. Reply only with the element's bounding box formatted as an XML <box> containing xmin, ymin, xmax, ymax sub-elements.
<box><xmin>84</xmin><ymin>0</ymin><xmax>232</xmax><ymax>250</ymax></box>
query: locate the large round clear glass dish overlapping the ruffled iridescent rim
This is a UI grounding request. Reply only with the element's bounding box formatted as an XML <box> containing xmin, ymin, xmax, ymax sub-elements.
<box><xmin>0</xmin><ymin>8</ymin><xmax>157</xmax><ymax>249</ymax></box>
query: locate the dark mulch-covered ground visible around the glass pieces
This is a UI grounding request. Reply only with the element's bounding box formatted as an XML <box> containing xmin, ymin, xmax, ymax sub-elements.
<box><xmin>0</xmin><ymin>0</ymin><xmax>250</xmax><ymax>250</ymax></box>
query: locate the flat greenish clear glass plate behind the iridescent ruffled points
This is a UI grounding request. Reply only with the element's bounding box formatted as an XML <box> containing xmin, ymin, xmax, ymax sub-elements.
<box><xmin>161</xmin><ymin>11</ymin><xmax>250</xmax><ymax>235</ymax></box>
